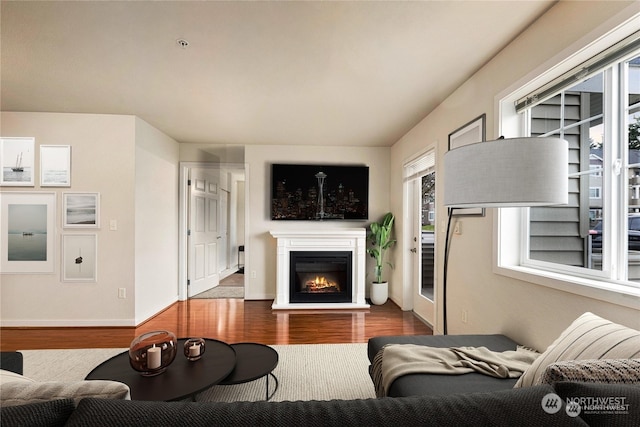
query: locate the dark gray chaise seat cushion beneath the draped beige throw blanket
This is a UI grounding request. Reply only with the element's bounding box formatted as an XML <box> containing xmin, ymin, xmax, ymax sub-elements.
<box><xmin>367</xmin><ymin>335</ymin><xmax>518</xmax><ymax>397</ymax></box>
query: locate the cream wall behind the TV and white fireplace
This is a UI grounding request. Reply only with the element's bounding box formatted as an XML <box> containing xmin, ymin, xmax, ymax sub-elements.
<box><xmin>245</xmin><ymin>145</ymin><xmax>390</xmax><ymax>299</ymax></box>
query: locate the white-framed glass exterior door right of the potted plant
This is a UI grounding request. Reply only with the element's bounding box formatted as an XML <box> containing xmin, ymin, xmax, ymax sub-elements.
<box><xmin>403</xmin><ymin>151</ymin><xmax>437</xmax><ymax>326</ymax></box>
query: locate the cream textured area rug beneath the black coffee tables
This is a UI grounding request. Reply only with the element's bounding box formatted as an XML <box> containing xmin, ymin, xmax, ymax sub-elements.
<box><xmin>22</xmin><ymin>344</ymin><xmax>375</xmax><ymax>402</ymax></box>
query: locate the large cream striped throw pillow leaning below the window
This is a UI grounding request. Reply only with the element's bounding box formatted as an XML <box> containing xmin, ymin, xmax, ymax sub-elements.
<box><xmin>514</xmin><ymin>312</ymin><xmax>640</xmax><ymax>387</ymax></box>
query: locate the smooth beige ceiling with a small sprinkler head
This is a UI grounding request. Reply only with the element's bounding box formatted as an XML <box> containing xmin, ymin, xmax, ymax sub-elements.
<box><xmin>0</xmin><ymin>0</ymin><xmax>554</xmax><ymax>146</ymax></box>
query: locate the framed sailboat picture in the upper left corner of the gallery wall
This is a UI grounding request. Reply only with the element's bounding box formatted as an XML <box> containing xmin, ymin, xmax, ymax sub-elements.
<box><xmin>0</xmin><ymin>138</ymin><xmax>35</xmax><ymax>187</ymax></box>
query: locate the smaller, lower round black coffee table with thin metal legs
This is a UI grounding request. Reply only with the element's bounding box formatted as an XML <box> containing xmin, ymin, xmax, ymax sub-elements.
<box><xmin>218</xmin><ymin>342</ymin><xmax>278</xmax><ymax>400</ymax></box>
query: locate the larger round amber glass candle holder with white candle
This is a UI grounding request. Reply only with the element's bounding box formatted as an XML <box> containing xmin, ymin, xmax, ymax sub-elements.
<box><xmin>129</xmin><ymin>331</ymin><xmax>178</xmax><ymax>377</ymax></box>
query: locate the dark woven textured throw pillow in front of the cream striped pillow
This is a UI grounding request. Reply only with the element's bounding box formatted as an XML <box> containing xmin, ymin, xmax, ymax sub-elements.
<box><xmin>540</xmin><ymin>359</ymin><xmax>640</xmax><ymax>384</ymax></box>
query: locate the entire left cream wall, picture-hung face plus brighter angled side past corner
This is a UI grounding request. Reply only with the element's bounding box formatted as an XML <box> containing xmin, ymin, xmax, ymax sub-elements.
<box><xmin>0</xmin><ymin>112</ymin><xmax>178</xmax><ymax>326</ymax></box>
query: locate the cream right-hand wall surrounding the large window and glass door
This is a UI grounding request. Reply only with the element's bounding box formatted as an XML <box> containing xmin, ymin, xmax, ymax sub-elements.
<box><xmin>391</xmin><ymin>2</ymin><xmax>640</xmax><ymax>349</ymax></box>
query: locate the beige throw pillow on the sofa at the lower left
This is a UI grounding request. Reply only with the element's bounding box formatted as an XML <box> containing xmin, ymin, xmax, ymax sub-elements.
<box><xmin>0</xmin><ymin>380</ymin><xmax>131</xmax><ymax>406</ymax></box>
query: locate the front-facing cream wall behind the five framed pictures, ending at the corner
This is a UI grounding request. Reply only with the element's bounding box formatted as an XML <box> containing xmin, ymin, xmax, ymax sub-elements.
<box><xmin>0</xmin><ymin>112</ymin><xmax>135</xmax><ymax>326</ymax></box>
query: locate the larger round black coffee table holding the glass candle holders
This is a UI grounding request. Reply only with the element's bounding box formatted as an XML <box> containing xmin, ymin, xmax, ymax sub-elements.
<box><xmin>85</xmin><ymin>339</ymin><xmax>236</xmax><ymax>401</ymax></box>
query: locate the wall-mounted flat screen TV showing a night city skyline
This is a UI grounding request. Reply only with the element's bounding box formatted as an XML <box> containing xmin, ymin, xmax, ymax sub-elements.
<box><xmin>271</xmin><ymin>164</ymin><xmax>369</xmax><ymax>221</ymax></box>
